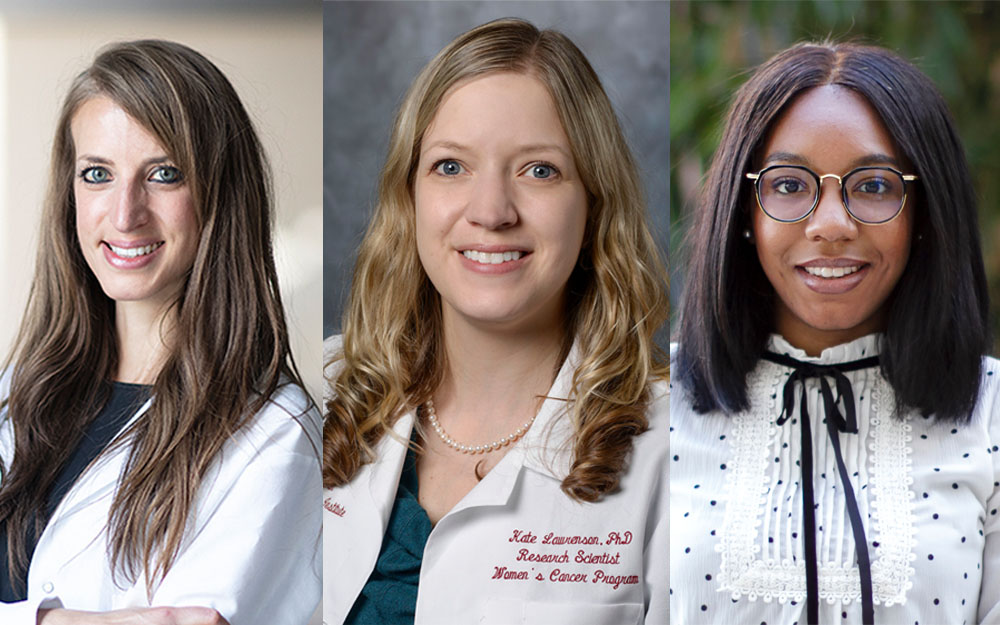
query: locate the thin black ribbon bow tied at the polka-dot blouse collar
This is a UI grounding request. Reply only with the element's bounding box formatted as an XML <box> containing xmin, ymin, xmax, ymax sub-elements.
<box><xmin>763</xmin><ymin>352</ymin><xmax>879</xmax><ymax>625</ymax></box>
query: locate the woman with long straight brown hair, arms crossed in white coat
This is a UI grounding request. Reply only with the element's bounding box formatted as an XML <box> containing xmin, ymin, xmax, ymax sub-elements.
<box><xmin>0</xmin><ymin>40</ymin><xmax>320</xmax><ymax>625</ymax></box>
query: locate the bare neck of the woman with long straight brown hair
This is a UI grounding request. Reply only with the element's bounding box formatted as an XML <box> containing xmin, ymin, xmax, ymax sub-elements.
<box><xmin>115</xmin><ymin>302</ymin><xmax>177</xmax><ymax>384</ymax></box>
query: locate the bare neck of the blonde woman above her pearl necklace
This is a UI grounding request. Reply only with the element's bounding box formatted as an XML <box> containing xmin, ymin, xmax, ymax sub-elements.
<box><xmin>434</xmin><ymin>311</ymin><xmax>562</xmax><ymax>438</ymax></box>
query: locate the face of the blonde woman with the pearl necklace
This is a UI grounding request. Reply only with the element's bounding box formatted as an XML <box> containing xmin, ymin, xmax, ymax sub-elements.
<box><xmin>413</xmin><ymin>72</ymin><xmax>587</xmax><ymax>328</ymax></box>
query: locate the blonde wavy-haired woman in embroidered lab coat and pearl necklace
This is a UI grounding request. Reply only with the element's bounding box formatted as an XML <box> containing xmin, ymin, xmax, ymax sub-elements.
<box><xmin>323</xmin><ymin>19</ymin><xmax>668</xmax><ymax>625</ymax></box>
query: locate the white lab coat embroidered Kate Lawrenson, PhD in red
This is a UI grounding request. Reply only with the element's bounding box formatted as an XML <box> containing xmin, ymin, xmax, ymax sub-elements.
<box><xmin>323</xmin><ymin>338</ymin><xmax>669</xmax><ymax>625</ymax></box>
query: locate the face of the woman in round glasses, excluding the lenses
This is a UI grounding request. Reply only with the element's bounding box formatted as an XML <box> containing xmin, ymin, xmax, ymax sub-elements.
<box><xmin>751</xmin><ymin>85</ymin><xmax>914</xmax><ymax>354</ymax></box>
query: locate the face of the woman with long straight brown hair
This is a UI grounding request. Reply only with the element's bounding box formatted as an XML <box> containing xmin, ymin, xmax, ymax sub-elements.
<box><xmin>72</xmin><ymin>96</ymin><xmax>200</xmax><ymax>308</ymax></box>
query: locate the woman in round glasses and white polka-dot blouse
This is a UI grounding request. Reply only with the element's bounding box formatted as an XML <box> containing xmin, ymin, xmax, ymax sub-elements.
<box><xmin>670</xmin><ymin>44</ymin><xmax>1000</xmax><ymax>625</ymax></box>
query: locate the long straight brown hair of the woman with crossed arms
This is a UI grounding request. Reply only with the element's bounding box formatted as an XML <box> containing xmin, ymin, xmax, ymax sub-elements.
<box><xmin>0</xmin><ymin>40</ymin><xmax>301</xmax><ymax>593</ymax></box>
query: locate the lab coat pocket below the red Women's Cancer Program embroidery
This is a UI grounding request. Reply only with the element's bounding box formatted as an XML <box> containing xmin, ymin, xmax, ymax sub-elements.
<box><xmin>479</xmin><ymin>599</ymin><xmax>643</xmax><ymax>625</ymax></box>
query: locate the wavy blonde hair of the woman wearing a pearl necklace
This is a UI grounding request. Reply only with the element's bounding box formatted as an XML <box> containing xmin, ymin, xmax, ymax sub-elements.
<box><xmin>323</xmin><ymin>19</ymin><xmax>668</xmax><ymax>501</ymax></box>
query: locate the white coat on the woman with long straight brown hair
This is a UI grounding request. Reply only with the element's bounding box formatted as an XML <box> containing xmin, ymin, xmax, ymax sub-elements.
<box><xmin>0</xmin><ymin>376</ymin><xmax>322</xmax><ymax>625</ymax></box>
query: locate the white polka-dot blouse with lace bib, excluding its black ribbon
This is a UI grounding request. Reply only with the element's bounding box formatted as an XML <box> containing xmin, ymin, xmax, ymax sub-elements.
<box><xmin>670</xmin><ymin>335</ymin><xmax>1000</xmax><ymax>625</ymax></box>
